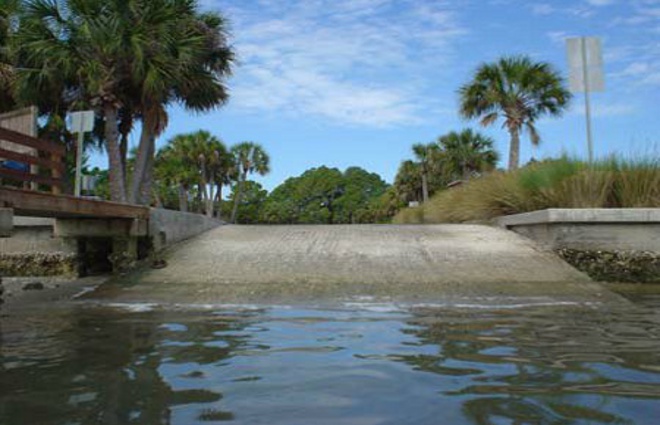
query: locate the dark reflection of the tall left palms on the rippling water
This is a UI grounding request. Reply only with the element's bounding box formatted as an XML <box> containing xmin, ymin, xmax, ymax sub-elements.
<box><xmin>0</xmin><ymin>308</ymin><xmax>258</xmax><ymax>424</ymax></box>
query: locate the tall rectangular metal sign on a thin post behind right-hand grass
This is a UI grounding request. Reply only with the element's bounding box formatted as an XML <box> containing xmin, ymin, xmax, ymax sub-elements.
<box><xmin>566</xmin><ymin>37</ymin><xmax>605</xmax><ymax>162</ymax></box>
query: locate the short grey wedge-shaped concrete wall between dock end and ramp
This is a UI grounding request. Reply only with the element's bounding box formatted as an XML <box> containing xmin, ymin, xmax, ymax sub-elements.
<box><xmin>149</xmin><ymin>208</ymin><xmax>222</xmax><ymax>251</ymax></box>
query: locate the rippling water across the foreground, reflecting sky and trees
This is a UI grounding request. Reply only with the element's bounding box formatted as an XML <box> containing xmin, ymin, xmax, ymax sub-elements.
<box><xmin>0</xmin><ymin>294</ymin><xmax>660</xmax><ymax>425</ymax></box>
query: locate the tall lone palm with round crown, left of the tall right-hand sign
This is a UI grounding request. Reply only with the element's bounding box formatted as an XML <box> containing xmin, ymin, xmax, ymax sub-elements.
<box><xmin>459</xmin><ymin>56</ymin><xmax>571</xmax><ymax>170</ymax></box>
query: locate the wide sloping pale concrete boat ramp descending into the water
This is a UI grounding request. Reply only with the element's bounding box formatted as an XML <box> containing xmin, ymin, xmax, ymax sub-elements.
<box><xmin>96</xmin><ymin>225</ymin><xmax>628</xmax><ymax>303</ymax></box>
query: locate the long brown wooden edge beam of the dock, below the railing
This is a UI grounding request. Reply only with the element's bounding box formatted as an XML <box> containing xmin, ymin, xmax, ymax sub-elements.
<box><xmin>0</xmin><ymin>188</ymin><xmax>149</xmax><ymax>220</ymax></box>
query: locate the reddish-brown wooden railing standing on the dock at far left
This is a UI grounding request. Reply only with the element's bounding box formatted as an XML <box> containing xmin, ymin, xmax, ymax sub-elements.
<box><xmin>0</xmin><ymin>127</ymin><xmax>65</xmax><ymax>195</ymax></box>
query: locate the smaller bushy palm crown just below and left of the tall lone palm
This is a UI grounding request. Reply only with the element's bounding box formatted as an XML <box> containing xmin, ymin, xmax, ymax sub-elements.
<box><xmin>438</xmin><ymin>129</ymin><xmax>499</xmax><ymax>180</ymax></box>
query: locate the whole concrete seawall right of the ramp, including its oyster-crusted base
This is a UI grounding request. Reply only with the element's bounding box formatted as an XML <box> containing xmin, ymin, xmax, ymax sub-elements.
<box><xmin>498</xmin><ymin>208</ymin><xmax>660</xmax><ymax>283</ymax></box>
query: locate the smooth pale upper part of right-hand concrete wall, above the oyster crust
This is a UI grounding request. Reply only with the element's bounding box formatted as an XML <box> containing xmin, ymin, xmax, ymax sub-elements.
<box><xmin>498</xmin><ymin>208</ymin><xmax>660</xmax><ymax>253</ymax></box>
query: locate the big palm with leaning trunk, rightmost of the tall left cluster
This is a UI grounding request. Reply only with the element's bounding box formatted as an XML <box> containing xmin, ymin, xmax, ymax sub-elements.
<box><xmin>129</xmin><ymin>4</ymin><xmax>234</xmax><ymax>203</ymax></box>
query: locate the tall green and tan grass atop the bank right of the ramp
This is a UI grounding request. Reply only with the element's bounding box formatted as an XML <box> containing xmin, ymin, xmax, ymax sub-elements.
<box><xmin>394</xmin><ymin>157</ymin><xmax>660</xmax><ymax>223</ymax></box>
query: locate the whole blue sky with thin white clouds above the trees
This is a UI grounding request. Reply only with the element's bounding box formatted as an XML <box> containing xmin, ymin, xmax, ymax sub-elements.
<box><xmin>91</xmin><ymin>0</ymin><xmax>660</xmax><ymax>189</ymax></box>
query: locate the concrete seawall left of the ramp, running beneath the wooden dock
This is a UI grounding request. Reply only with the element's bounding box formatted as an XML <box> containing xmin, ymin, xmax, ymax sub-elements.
<box><xmin>0</xmin><ymin>208</ymin><xmax>222</xmax><ymax>276</ymax></box>
